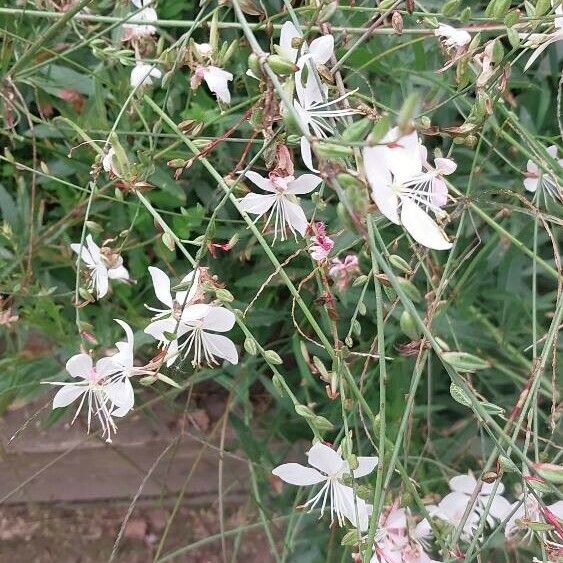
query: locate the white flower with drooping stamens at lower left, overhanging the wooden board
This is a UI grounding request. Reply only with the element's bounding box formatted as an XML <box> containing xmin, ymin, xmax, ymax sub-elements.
<box><xmin>47</xmin><ymin>319</ymin><xmax>145</xmax><ymax>442</ymax></box>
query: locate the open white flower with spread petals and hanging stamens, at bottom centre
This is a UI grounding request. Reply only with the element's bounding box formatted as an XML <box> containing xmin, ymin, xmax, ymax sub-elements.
<box><xmin>272</xmin><ymin>442</ymin><xmax>378</xmax><ymax>531</ymax></box>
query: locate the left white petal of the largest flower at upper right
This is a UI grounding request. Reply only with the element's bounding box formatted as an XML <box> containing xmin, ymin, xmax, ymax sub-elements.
<box><xmin>363</xmin><ymin>147</ymin><xmax>400</xmax><ymax>225</ymax></box>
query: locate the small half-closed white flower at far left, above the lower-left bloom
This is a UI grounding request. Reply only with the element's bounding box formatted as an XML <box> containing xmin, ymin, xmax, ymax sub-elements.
<box><xmin>70</xmin><ymin>235</ymin><xmax>129</xmax><ymax>299</ymax></box>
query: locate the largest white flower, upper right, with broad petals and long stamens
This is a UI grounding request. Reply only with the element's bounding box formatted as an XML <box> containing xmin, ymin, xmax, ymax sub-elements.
<box><xmin>363</xmin><ymin>127</ymin><xmax>452</xmax><ymax>250</ymax></box>
